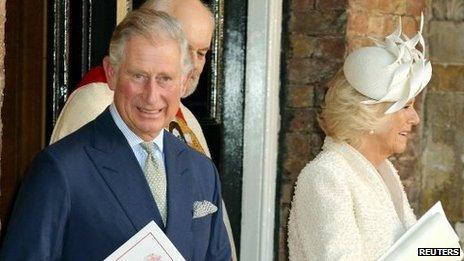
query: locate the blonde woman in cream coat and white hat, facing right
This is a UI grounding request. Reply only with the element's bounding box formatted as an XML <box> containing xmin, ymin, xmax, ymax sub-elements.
<box><xmin>288</xmin><ymin>17</ymin><xmax>431</xmax><ymax>261</ymax></box>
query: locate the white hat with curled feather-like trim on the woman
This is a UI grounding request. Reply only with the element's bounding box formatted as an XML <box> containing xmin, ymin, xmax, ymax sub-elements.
<box><xmin>343</xmin><ymin>15</ymin><xmax>432</xmax><ymax>114</ymax></box>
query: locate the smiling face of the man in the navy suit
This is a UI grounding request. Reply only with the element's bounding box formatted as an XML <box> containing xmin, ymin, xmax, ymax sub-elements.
<box><xmin>104</xmin><ymin>36</ymin><xmax>184</xmax><ymax>141</ymax></box>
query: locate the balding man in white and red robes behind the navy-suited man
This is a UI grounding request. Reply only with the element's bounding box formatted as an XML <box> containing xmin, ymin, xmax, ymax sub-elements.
<box><xmin>50</xmin><ymin>0</ymin><xmax>237</xmax><ymax>260</ymax></box>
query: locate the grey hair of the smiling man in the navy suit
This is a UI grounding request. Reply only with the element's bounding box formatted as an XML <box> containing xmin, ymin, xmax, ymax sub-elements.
<box><xmin>109</xmin><ymin>8</ymin><xmax>192</xmax><ymax>76</ymax></box>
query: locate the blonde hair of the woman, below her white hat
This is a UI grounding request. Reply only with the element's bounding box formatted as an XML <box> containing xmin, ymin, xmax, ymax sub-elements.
<box><xmin>318</xmin><ymin>70</ymin><xmax>391</xmax><ymax>147</ymax></box>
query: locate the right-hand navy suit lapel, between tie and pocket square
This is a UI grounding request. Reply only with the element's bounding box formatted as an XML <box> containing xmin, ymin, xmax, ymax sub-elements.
<box><xmin>164</xmin><ymin>132</ymin><xmax>193</xmax><ymax>254</ymax></box>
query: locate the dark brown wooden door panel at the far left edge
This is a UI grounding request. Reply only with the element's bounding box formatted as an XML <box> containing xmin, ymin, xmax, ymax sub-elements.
<box><xmin>0</xmin><ymin>0</ymin><xmax>47</xmax><ymax>238</ymax></box>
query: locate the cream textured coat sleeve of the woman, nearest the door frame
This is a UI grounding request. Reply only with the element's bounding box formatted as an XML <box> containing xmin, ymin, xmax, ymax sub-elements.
<box><xmin>289</xmin><ymin>166</ymin><xmax>363</xmax><ymax>260</ymax></box>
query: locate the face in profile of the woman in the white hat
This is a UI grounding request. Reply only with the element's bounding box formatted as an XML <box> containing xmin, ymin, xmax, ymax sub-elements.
<box><xmin>373</xmin><ymin>99</ymin><xmax>420</xmax><ymax>156</ymax></box>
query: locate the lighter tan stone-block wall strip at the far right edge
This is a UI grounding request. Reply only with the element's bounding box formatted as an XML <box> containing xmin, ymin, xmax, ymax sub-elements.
<box><xmin>422</xmin><ymin>0</ymin><xmax>464</xmax><ymax>242</ymax></box>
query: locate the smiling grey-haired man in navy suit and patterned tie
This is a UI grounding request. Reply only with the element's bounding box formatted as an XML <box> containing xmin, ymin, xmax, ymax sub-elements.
<box><xmin>0</xmin><ymin>8</ymin><xmax>231</xmax><ymax>260</ymax></box>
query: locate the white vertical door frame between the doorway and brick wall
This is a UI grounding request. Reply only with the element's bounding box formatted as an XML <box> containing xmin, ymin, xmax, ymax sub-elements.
<box><xmin>240</xmin><ymin>0</ymin><xmax>282</xmax><ymax>260</ymax></box>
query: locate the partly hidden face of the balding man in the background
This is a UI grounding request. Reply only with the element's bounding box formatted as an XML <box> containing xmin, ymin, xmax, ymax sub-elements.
<box><xmin>173</xmin><ymin>1</ymin><xmax>214</xmax><ymax>97</ymax></box>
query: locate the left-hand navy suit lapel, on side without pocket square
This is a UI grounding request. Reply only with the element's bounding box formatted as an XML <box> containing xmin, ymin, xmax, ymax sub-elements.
<box><xmin>86</xmin><ymin>109</ymin><xmax>164</xmax><ymax>231</ymax></box>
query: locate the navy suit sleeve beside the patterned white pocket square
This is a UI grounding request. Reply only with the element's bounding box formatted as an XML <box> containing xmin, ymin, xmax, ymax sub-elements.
<box><xmin>205</xmin><ymin>163</ymin><xmax>232</xmax><ymax>261</ymax></box>
